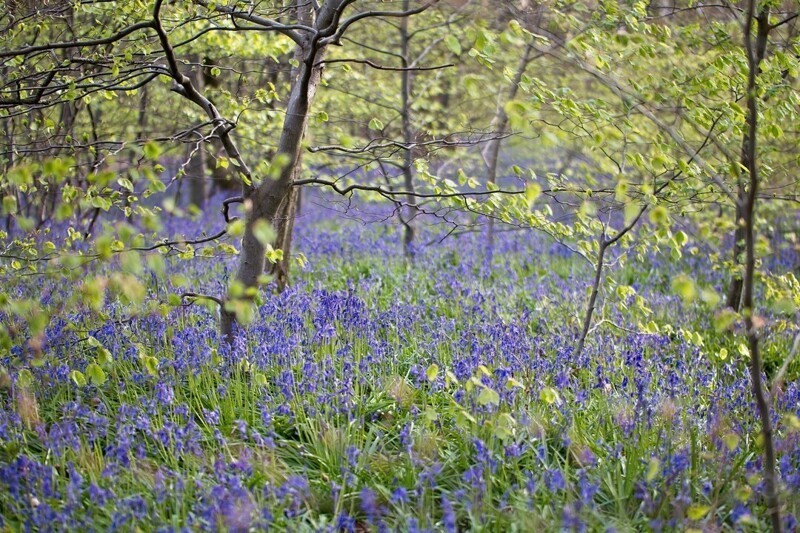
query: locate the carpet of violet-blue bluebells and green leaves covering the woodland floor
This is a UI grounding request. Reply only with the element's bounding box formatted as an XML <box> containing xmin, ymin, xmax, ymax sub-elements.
<box><xmin>0</xmin><ymin>196</ymin><xmax>800</xmax><ymax>532</ymax></box>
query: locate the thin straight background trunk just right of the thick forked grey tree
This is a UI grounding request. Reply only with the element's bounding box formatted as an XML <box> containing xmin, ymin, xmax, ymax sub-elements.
<box><xmin>400</xmin><ymin>0</ymin><xmax>417</xmax><ymax>258</ymax></box>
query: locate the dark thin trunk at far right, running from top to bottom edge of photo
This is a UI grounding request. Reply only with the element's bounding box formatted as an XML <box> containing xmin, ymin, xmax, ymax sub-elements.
<box><xmin>742</xmin><ymin>0</ymin><xmax>783</xmax><ymax>532</ymax></box>
